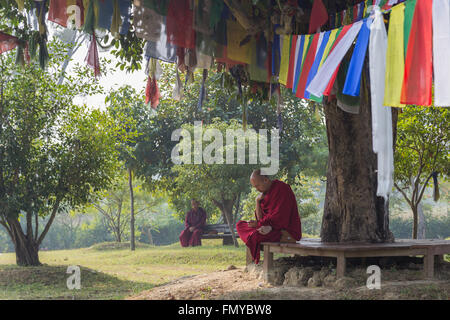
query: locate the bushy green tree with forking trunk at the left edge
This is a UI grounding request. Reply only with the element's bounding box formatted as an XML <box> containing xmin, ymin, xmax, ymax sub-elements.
<box><xmin>0</xmin><ymin>42</ymin><xmax>125</xmax><ymax>266</ymax></box>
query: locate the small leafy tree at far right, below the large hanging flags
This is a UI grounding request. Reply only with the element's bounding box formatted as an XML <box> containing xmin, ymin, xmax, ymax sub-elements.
<box><xmin>394</xmin><ymin>107</ymin><xmax>450</xmax><ymax>239</ymax></box>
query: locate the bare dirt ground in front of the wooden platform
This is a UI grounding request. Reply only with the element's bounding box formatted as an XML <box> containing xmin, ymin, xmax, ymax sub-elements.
<box><xmin>128</xmin><ymin>268</ymin><xmax>450</xmax><ymax>300</ymax></box>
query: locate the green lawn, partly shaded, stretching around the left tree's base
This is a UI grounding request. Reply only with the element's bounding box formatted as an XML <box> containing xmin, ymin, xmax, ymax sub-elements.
<box><xmin>0</xmin><ymin>240</ymin><xmax>245</xmax><ymax>299</ymax></box>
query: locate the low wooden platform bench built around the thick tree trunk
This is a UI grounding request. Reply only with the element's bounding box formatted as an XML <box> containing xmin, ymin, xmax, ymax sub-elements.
<box><xmin>253</xmin><ymin>238</ymin><xmax>450</xmax><ymax>280</ymax></box>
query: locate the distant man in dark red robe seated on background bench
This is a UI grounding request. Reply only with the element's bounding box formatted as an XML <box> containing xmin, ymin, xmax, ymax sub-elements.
<box><xmin>180</xmin><ymin>199</ymin><xmax>206</xmax><ymax>247</ymax></box>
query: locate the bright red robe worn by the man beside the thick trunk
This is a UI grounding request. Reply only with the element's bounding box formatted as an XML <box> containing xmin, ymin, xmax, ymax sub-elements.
<box><xmin>236</xmin><ymin>180</ymin><xmax>302</xmax><ymax>263</ymax></box>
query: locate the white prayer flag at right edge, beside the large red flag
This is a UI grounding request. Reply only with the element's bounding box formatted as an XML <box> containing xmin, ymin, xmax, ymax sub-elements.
<box><xmin>433</xmin><ymin>0</ymin><xmax>450</xmax><ymax>106</ymax></box>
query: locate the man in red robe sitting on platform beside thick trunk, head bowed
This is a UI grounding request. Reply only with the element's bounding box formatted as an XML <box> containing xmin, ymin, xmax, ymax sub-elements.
<box><xmin>236</xmin><ymin>170</ymin><xmax>302</xmax><ymax>264</ymax></box>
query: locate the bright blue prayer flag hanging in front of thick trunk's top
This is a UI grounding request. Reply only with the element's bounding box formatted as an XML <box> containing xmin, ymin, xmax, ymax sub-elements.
<box><xmin>343</xmin><ymin>18</ymin><xmax>372</xmax><ymax>97</ymax></box>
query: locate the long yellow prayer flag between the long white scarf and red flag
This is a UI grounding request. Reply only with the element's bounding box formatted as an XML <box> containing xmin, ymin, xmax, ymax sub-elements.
<box><xmin>384</xmin><ymin>3</ymin><xmax>406</xmax><ymax>107</ymax></box>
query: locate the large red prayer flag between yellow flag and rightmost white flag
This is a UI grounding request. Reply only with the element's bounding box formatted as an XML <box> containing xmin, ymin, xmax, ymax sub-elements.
<box><xmin>400</xmin><ymin>1</ymin><xmax>433</xmax><ymax>106</ymax></box>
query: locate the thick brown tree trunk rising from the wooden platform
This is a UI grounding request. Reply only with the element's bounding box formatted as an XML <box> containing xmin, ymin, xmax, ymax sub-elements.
<box><xmin>321</xmin><ymin>72</ymin><xmax>397</xmax><ymax>242</ymax></box>
